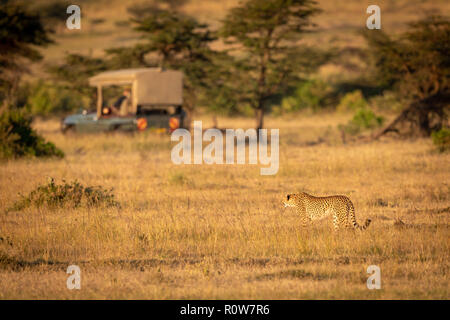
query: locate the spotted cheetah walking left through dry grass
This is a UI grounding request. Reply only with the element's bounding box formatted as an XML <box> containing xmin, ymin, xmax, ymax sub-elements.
<box><xmin>284</xmin><ymin>192</ymin><xmax>371</xmax><ymax>231</ymax></box>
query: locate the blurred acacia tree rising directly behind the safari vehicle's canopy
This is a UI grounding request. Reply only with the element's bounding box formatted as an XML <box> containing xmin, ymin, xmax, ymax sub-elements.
<box><xmin>128</xmin><ymin>10</ymin><xmax>216</xmax><ymax>127</ymax></box>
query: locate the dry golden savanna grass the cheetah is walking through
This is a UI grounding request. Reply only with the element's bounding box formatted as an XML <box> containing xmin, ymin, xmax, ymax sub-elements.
<box><xmin>0</xmin><ymin>114</ymin><xmax>450</xmax><ymax>299</ymax></box>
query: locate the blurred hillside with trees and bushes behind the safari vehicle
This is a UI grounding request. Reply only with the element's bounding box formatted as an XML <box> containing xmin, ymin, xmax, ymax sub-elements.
<box><xmin>0</xmin><ymin>0</ymin><xmax>450</xmax><ymax>156</ymax></box>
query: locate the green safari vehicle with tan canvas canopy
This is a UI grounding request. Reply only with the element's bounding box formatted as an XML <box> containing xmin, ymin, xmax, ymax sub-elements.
<box><xmin>61</xmin><ymin>68</ymin><xmax>185</xmax><ymax>133</ymax></box>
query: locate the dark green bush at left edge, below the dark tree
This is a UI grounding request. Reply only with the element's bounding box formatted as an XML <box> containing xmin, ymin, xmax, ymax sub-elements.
<box><xmin>0</xmin><ymin>110</ymin><xmax>64</xmax><ymax>158</ymax></box>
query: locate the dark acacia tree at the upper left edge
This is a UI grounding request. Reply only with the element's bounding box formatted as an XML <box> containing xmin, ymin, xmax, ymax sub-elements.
<box><xmin>0</xmin><ymin>1</ymin><xmax>52</xmax><ymax>109</ymax></box>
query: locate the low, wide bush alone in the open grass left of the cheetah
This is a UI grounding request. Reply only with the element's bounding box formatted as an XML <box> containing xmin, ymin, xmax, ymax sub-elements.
<box><xmin>8</xmin><ymin>178</ymin><xmax>120</xmax><ymax>211</ymax></box>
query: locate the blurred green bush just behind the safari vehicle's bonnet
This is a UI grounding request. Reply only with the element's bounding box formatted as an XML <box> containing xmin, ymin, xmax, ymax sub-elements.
<box><xmin>27</xmin><ymin>81</ymin><xmax>89</xmax><ymax>116</ymax></box>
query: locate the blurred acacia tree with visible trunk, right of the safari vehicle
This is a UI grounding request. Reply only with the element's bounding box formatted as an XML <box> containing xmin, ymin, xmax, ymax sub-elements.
<box><xmin>220</xmin><ymin>0</ymin><xmax>319</xmax><ymax>129</ymax></box>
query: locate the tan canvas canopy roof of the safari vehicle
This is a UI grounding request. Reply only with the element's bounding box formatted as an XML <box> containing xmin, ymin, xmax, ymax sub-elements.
<box><xmin>89</xmin><ymin>68</ymin><xmax>183</xmax><ymax>110</ymax></box>
